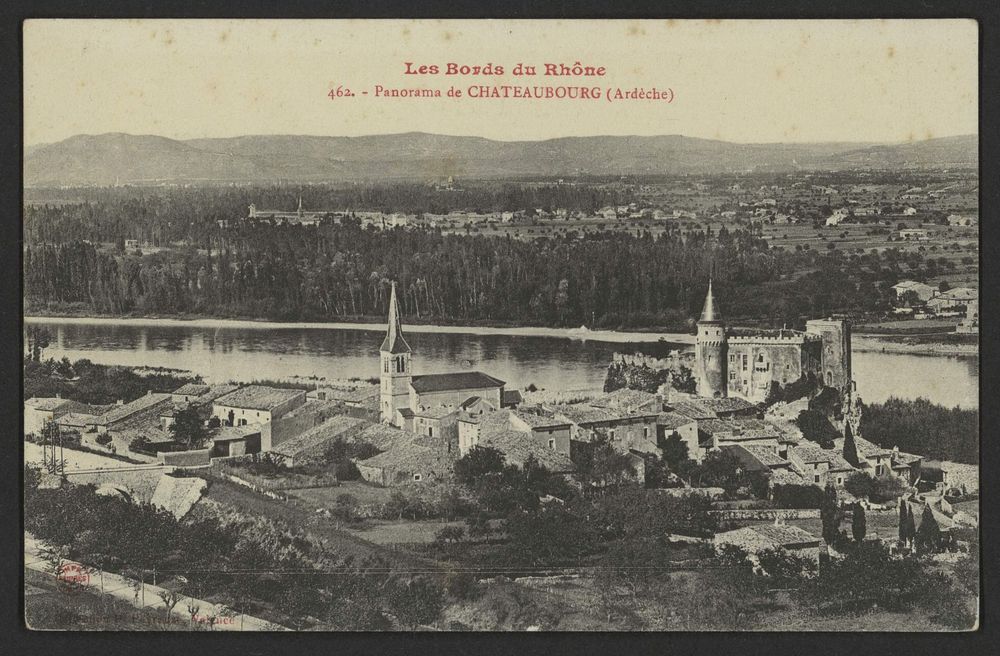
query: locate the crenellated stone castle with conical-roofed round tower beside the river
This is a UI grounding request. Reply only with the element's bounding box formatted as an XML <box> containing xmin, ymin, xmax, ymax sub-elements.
<box><xmin>694</xmin><ymin>279</ymin><xmax>852</xmax><ymax>403</ymax></box>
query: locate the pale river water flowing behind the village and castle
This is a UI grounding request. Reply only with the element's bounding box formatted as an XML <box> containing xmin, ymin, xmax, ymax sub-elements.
<box><xmin>31</xmin><ymin>320</ymin><xmax>979</xmax><ymax>408</ymax></box>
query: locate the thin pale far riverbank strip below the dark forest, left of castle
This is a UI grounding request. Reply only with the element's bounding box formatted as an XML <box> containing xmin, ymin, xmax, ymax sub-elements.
<box><xmin>24</xmin><ymin>315</ymin><xmax>694</xmax><ymax>344</ymax></box>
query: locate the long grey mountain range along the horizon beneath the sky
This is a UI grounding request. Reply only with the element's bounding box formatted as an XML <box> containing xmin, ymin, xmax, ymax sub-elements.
<box><xmin>24</xmin><ymin>132</ymin><xmax>978</xmax><ymax>186</ymax></box>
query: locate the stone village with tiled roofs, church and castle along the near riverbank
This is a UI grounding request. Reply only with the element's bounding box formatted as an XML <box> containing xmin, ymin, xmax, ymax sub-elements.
<box><xmin>24</xmin><ymin>281</ymin><xmax>978</xmax><ymax>632</ymax></box>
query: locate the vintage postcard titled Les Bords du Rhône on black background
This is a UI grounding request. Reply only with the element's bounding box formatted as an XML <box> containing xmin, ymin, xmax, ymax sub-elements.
<box><xmin>22</xmin><ymin>19</ymin><xmax>980</xmax><ymax>632</ymax></box>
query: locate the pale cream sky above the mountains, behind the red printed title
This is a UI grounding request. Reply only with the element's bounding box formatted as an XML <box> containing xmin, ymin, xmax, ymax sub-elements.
<box><xmin>24</xmin><ymin>19</ymin><xmax>978</xmax><ymax>145</ymax></box>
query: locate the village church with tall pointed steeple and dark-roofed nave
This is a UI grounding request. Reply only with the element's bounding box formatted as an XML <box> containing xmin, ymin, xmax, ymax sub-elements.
<box><xmin>379</xmin><ymin>282</ymin><xmax>505</xmax><ymax>430</ymax></box>
